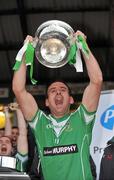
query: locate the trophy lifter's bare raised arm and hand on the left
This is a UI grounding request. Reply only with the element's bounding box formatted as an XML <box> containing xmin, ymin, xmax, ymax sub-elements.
<box><xmin>12</xmin><ymin>36</ymin><xmax>38</xmax><ymax>120</ymax></box>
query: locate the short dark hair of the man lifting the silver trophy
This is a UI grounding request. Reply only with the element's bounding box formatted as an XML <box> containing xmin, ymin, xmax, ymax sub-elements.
<box><xmin>45</xmin><ymin>79</ymin><xmax>71</xmax><ymax>98</ymax></box>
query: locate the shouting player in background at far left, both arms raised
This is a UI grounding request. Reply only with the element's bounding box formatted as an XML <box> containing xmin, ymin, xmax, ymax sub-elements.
<box><xmin>0</xmin><ymin>103</ymin><xmax>28</xmax><ymax>171</ymax></box>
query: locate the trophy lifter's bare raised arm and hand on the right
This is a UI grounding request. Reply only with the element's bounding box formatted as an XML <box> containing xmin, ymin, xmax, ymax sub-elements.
<box><xmin>76</xmin><ymin>31</ymin><xmax>103</xmax><ymax>112</ymax></box>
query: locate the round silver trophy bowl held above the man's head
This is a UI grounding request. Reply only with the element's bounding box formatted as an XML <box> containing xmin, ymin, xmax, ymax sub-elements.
<box><xmin>35</xmin><ymin>20</ymin><xmax>74</xmax><ymax>68</ymax></box>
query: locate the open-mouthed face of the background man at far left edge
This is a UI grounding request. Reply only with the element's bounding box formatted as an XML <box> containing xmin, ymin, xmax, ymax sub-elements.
<box><xmin>0</xmin><ymin>136</ymin><xmax>12</xmax><ymax>156</ymax></box>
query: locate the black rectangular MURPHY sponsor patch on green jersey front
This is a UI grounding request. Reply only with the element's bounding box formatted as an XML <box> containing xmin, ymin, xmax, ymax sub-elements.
<box><xmin>43</xmin><ymin>144</ymin><xmax>78</xmax><ymax>156</ymax></box>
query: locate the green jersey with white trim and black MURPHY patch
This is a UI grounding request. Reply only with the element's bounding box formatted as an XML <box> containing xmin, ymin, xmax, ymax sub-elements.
<box><xmin>29</xmin><ymin>105</ymin><xmax>95</xmax><ymax>180</ymax></box>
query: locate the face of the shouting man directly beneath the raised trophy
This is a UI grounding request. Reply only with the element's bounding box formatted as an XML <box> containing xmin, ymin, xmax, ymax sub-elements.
<box><xmin>46</xmin><ymin>82</ymin><xmax>73</xmax><ymax>118</ymax></box>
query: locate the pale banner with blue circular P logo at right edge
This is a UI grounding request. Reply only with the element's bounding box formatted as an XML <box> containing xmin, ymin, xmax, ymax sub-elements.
<box><xmin>90</xmin><ymin>90</ymin><xmax>114</xmax><ymax>180</ymax></box>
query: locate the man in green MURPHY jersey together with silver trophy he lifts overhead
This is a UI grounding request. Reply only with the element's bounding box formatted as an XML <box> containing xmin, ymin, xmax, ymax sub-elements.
<box><xmin>12</xmin><ymin>20</ymin><xmax>102</xmax><ymax>180</ymax></box>
